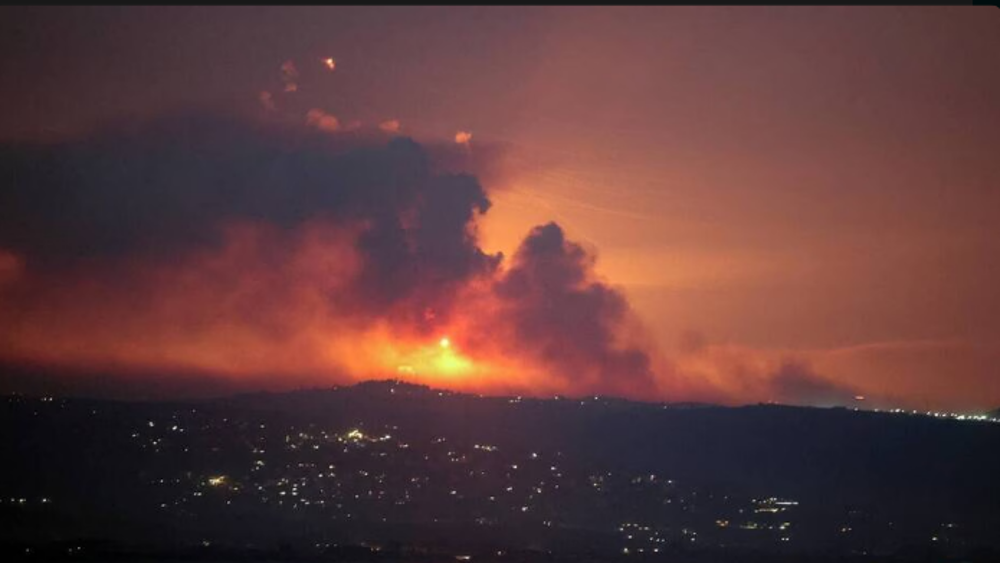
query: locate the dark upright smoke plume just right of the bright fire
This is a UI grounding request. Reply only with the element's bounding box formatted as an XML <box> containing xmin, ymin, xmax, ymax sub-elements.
<box><xmin>496</xmin><ymin>223</ymin><xmax>654</xmax><ymax>395</ymax></box>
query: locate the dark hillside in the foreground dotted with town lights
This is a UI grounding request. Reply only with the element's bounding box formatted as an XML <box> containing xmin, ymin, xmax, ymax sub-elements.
<box><xmin>0</xmin><ymin>382</ymin><xmax>1000</xmax><ymax>563</ymax></box>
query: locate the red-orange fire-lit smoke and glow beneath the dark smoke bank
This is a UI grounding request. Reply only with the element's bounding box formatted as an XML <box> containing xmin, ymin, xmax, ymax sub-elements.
<box><xmin>0</xmin><ymin>223</ymin><xmax>568</xmax><ymax>400</ymax></box>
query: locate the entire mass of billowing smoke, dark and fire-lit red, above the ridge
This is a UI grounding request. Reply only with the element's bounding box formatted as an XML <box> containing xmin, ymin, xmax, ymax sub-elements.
<box><xmin>0</xmin><ymin>109</ymin><xmax>860</xmax><ymax>406</ymax></box>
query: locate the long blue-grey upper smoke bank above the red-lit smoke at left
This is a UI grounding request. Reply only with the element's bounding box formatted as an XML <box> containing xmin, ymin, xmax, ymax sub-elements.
<box><xmin>0</xmin><ymin>110</ymin><xmax>499</xmax><ymax>324</ymax></box>
